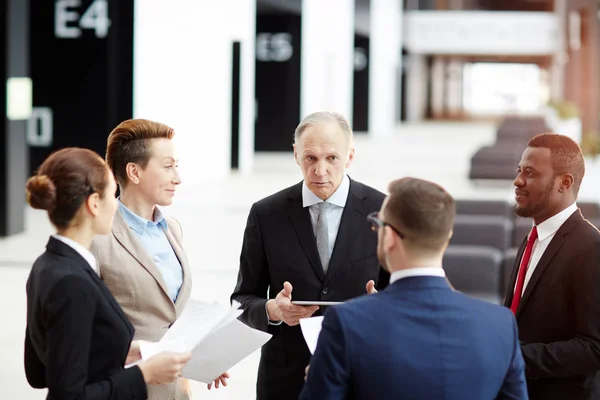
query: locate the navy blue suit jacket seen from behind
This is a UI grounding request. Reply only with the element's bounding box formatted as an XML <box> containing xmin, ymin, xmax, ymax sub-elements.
<box><xmin>300</xmin><ymin>276</ymin><xmax>527</xmax><ymax>400</ymax></box>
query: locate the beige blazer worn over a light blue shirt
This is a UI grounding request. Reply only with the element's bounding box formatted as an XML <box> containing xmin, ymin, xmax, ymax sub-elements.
<box><xmin>91</xmin><ymin>212</ymin><xmax>192</xmax><ymax>400</ymax></box>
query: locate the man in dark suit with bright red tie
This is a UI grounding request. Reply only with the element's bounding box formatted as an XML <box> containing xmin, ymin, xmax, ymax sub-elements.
<box><xmin>504</xmin><ymin>133</ymin><xmax>600</xmax><ymax>400</ymax></box>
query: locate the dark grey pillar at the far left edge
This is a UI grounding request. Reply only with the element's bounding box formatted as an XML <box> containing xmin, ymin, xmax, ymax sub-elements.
<box><xmin>0</xmin><ymin>0</ymin><xmax>29</xmax><ymax>237</ymax></box>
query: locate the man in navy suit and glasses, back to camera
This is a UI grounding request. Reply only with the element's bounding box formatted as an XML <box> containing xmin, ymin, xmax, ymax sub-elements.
<box><xmin>300</xmin><ymin>178</ymin><xmax>527</xmax><ymax>400</ymax></box>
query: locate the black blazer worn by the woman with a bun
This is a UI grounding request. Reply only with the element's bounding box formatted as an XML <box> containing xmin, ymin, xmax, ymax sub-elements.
<box><xmin>25</xmin><ymin>238</ymin><xmax>147</xmax><ymax>400</ymax></box>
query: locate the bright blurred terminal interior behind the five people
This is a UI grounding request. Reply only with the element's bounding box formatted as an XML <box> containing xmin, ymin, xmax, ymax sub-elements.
<box><xmin>0</xmin><ymin>0</ymin><xmax>600</xmax><ymax>400</ymax></box>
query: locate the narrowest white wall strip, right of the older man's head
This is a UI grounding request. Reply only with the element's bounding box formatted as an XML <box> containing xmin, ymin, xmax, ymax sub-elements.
<box><xmin>369</xmin><ymin>0</ymin><xmax>403</xmax><ymax>136</ymax></box>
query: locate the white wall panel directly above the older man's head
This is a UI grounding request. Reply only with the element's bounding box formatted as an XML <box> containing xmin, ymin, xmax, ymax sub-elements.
<box><xmin>300</xmin><ymin>0</ymin><xmax>354</xmax><ymax>121</ymax></box>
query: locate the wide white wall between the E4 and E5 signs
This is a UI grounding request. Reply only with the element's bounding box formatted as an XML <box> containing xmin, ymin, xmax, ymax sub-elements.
<box><xmin>134</xmin><ymin>0</ymin><xmax>256</xmax><ymax>184</ymax></box>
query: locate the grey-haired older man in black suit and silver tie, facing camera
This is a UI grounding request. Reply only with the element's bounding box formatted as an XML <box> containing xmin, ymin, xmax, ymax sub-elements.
<box><xmin>231</xmin><ymin>112</ymin><xmax>389</xmax><ymax>400</ymax></box>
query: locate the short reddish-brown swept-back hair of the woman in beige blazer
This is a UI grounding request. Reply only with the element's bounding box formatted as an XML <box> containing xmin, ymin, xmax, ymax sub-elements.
<box><xmin>106</xmin><ymin>119</ymin><xmax>175</xmax><ymax>187</ymax></box>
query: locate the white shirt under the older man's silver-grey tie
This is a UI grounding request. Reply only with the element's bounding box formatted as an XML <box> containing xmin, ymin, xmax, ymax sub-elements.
<box><xmin>302</xmin><ymin>174</ymin><xmax>350</xmax><ymax>257</ymax></box>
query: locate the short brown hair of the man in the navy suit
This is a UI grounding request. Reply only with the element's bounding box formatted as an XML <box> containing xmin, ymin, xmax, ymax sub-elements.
<box><xmin>385</xmin><ymin>178</ymin><xmax>456</xmax><ymax>252</ymax></box>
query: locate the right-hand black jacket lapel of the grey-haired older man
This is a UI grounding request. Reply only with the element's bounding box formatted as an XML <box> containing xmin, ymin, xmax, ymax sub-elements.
<box><xmin>325</xmin><ymin>180</ymin><xmax>366</xmax><ymax>283</ymax></box>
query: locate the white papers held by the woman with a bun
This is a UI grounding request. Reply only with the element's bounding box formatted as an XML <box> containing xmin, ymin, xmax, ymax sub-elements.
<box><xmin>140</xmin><ymin>299</ymin><xmax>271</xmax><ymax>383</ymax></box>
